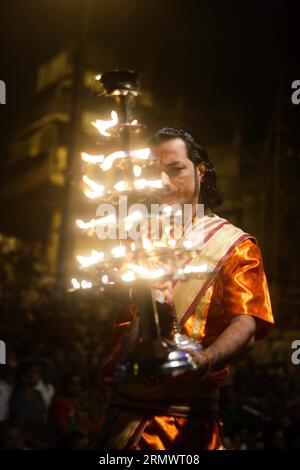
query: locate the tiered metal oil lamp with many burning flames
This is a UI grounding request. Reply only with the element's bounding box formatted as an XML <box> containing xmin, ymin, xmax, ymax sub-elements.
<box><xmin>72</xmin><ymin>71</ymin><xmax>211</xmax><ymax>378</ymax></box>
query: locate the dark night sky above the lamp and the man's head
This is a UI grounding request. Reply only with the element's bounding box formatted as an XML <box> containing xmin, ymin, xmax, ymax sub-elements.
<box><xmin>0</xmin><ymin>0</ymin><xmax>299</xmax><ymax>150</ymax></box>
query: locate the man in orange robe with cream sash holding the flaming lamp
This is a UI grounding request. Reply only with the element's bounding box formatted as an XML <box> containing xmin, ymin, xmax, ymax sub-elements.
<box><xmin>102</xmin><ymin>128</ymin><xmax>273</xmax><ymax>450</ymax></box>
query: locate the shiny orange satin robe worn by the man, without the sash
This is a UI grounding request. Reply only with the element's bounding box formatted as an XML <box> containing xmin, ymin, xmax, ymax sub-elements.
<box><xmin>103</xmin><ymin>239</ymin><xmax>274</xmax><ymax>450</ymax></box>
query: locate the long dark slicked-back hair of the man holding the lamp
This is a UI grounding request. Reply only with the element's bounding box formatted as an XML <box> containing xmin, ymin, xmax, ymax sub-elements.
<box><xmin>149</xmin><ymin>127</ymin><xmax>224</xmax><ymax>209</ymax></box>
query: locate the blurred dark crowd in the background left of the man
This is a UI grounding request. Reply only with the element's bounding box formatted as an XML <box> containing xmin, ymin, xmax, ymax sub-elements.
<box><xmin>0</xmin><ymin>350</ymin><xmax>108</xmax><ymax>449</ymax></box>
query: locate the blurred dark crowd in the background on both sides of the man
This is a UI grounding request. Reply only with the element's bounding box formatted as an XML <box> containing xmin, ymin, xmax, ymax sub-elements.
<box><xmin>0</xmin><ymin>348</ymin><xmax>300</xmax><ymax>450</ymax></box>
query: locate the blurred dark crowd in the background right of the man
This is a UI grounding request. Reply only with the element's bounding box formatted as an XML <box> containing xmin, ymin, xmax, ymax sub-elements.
<box><xmin>222</xmin><ymin>357</ymin><xmax>300</xmax><ymax>450</ymax></box>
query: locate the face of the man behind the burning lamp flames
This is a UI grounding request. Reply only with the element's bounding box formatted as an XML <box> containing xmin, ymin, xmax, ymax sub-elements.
<box><xmin>152</xmin><ymin>138</ymin><xmax>205</xmax><ymax>205</ymax></box>
